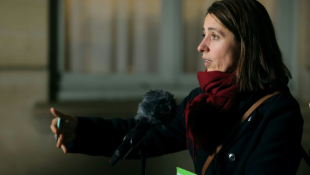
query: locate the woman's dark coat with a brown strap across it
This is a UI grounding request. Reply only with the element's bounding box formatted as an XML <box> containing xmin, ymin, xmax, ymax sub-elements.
<box><xmin>68</xmin><ymin>88</ymin><xmax>303</xmax><ymax>175</ymax></box>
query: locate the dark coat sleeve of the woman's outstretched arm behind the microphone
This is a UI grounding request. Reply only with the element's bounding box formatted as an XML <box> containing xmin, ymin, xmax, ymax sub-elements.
<box><xmin>67</xmin><ymin>88</ymin><xmax>200</xmax><ymax>159</ymax></box>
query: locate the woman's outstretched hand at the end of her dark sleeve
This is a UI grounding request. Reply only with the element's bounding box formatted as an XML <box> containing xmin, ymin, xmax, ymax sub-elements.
<box><xmin>50</xmin><ymin>108</ymin><xmax>78</xmax><ymax>153</ymax></box>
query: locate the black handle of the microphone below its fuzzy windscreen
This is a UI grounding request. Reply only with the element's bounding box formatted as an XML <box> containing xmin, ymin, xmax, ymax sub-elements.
<box><xmin>110</xmin><ymin>117</ymin><xmax>150</xmax><ymax>166</ymax></box>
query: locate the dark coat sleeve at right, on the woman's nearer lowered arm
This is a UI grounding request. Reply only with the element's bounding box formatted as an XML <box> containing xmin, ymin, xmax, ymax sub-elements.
<box><xmin>245</xmin><ymin>94</ymin><xmax>303</xmax><ymax>175</ymax></box>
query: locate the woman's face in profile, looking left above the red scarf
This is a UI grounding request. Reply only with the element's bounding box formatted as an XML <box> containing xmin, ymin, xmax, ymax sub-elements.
<box><xmin>198</xmin><ymin>14</ymin><xmax>240</xmax><ymax>72</ymax></box>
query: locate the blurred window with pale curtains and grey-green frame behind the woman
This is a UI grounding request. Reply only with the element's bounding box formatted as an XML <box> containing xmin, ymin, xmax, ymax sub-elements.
<box><xmin>53</xmin><ymin>0</ymin><xmax>216</xmax><ymax>100</ymax></box>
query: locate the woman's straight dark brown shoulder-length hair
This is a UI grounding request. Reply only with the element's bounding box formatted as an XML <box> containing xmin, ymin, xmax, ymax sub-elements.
<box><xmin>207</xmin><ymin>0</ymin><xmax>291</xmax><ymax>92</ymax></box>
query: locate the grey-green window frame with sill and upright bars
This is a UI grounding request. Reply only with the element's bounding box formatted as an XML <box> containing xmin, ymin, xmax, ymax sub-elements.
<box><xmin>51</xmin><ymin>0</ymin><xmax>199</xmax><ymax>101</ymax></box>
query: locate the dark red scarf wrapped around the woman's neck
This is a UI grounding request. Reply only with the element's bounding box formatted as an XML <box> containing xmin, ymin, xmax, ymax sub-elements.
<box><xmin>183</xmin><ymin>70</ymin><xmax>238</xmax><ymax>160</ymax></box>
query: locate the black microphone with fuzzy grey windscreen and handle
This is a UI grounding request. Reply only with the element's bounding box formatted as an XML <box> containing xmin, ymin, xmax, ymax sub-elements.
<box><xmin>110</xmin><ymin>89</ymin><xmax>177</xmax><ymax>166</ymax></box>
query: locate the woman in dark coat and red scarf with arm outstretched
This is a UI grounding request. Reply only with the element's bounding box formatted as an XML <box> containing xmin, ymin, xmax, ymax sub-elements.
<box><xmin>51</xmin><ymin>0</ymin><xmax>303</xmax><ymax>175</ymax></box>
